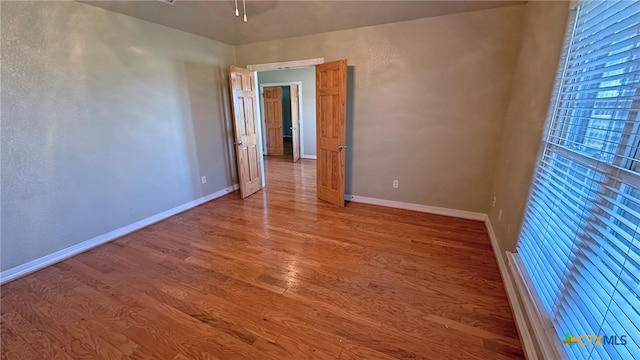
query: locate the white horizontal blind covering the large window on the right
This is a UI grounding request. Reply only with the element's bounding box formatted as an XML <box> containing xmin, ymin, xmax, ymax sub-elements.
<box><xmin>517</xmin><ymin>0</ymin><xmax>640</xmax><ymax>359</ymax></box>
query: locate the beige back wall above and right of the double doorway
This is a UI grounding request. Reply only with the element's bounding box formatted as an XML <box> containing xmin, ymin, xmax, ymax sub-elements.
<box><xmin>236</xmin><ymin>5</ymin><xmax>523</xmax><ymax>212</ymax></box>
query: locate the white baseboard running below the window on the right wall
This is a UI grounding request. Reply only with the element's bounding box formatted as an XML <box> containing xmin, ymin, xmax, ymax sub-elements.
<box><xmin>485</xmin><ymin>215</ymin><xmax>538</xmax><ymax>360</ymax></box>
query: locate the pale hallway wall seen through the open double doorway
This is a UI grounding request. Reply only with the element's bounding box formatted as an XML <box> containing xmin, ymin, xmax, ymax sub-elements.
<box><xmin>255</xmin><ymin>69</ymin><xmax>316</xmax><ymax>155</ymax></box>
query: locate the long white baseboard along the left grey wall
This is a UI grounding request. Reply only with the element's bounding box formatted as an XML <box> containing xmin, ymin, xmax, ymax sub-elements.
<box><xmin>0</xmin><ymin>184</ymin><xmax>239</xmax><ymax>284</ymax></box>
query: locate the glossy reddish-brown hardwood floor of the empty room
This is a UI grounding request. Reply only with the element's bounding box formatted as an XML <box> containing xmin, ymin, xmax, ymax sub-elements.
<box><xmin>1</xmin><ymin>158</ymin><xmax>523</xmax><ymax>360</ymax></box>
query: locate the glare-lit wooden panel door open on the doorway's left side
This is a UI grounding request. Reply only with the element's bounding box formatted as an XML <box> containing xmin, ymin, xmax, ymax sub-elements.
<box><xmin>229</xmin><ymin>66</ymin><xmax>262</xmax><ymax>199</ymax></box>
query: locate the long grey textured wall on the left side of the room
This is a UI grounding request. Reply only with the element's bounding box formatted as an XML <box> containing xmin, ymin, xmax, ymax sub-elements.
<box><xmin>0</xmin><ymin>1</ymin><xmax>235</xmax><ymax>270</ymax></box>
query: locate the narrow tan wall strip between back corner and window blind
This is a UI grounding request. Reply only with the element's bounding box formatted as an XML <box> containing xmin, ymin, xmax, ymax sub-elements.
<box><xmin>489</xmin><ymin>1</ymin><xmax>569</xmax><ymax>253</ymax></box>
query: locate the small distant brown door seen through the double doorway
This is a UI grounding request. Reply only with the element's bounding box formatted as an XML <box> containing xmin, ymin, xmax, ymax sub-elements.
<box><xmin>264</xmin><ymin>86</ymin><xmax>284</xmax><ymax>156</ymax></box>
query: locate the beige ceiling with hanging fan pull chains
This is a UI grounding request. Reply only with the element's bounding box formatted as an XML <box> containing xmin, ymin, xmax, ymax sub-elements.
<box><xmin>81</xmin><ymin>0</ymin><xmax>525</xmax><ymax>45</ymax></box>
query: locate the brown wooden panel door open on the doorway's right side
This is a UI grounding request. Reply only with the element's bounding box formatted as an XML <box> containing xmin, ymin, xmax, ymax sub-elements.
<box><xmin>316</xmin><ymin>60</ymin><xmax>347</xmax><ymax>207</ymax></box>
